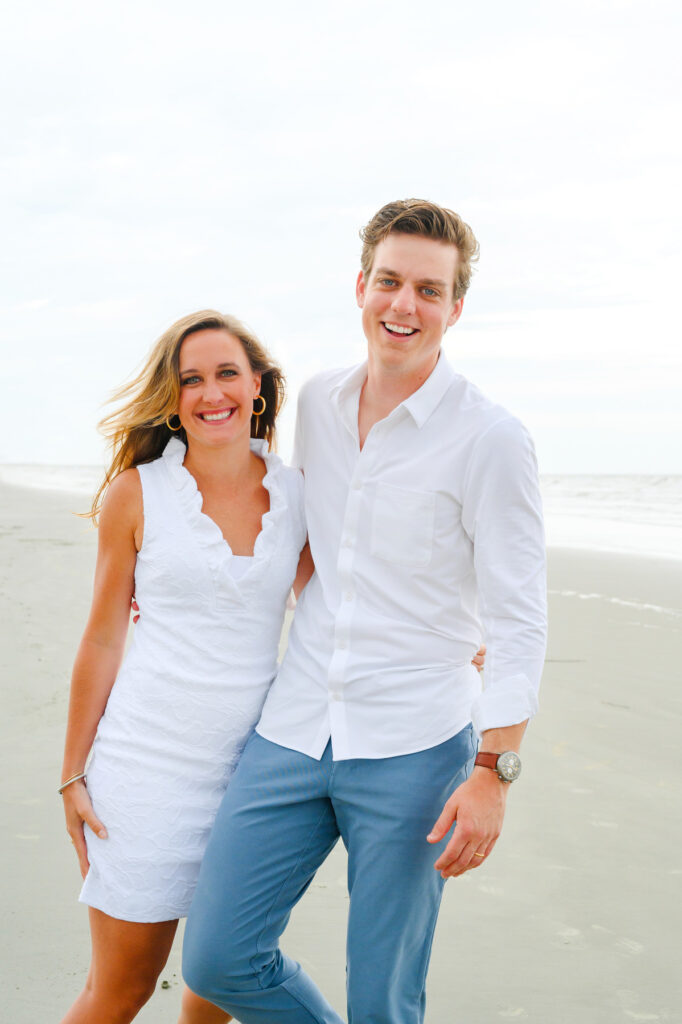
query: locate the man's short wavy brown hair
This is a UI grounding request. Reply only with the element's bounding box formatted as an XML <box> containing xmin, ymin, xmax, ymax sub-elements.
<box><xmin>360</xmin><ymin>199</ymin><xmax>478</xmax><ymax>301</ymax></box>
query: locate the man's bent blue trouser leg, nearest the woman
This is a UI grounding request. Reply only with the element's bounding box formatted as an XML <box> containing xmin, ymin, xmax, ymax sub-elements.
<box><xmin>182</xmin><ymin>733</ymin><xmax>342</xmax><ymax>1024</ymax></box>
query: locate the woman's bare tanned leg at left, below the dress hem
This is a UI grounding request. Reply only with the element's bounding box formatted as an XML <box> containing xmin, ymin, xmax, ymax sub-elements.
<box><xmin>61</xmin><ymin>907</ymin><xmax>178</xmax><ymax>1024</ymax></box>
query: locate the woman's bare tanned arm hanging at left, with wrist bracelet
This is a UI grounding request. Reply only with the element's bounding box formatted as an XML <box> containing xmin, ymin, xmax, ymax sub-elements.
<box><xmin>61</xmin><ymin>469</ymin><xmax>143</xmax><ymax>878</ymax></box>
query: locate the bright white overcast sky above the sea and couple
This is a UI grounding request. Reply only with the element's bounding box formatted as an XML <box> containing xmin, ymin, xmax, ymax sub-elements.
<box><xmin>0</xmin><ymin>0</ymin><xmax>682</xmax><ymax>473</ymax></box>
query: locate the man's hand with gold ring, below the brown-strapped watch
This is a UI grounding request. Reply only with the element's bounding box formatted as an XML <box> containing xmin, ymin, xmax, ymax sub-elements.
<box><xmin>427</xmin><ymin>768</ymin><xmax>509</xmax><ymax>879</ymax></box>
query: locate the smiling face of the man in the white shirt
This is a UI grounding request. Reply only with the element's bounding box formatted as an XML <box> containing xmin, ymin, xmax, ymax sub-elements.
<box><xmin>356</xmin><ymin>233</ymin><xmax>463</xmax><ymax>377</ymax></box>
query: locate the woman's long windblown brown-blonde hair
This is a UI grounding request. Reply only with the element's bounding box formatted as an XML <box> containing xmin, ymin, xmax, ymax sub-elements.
<box><xmin>89</xmin><ymin>309</ymin><xmax>286</xmax><ymax>521</ymax></box>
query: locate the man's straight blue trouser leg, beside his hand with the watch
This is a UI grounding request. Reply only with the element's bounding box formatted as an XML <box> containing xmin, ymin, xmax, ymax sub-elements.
<box><xmin>331</xmin><ymin>726</ymin><xmax>475</xmax><ymax>1024</ymax></box>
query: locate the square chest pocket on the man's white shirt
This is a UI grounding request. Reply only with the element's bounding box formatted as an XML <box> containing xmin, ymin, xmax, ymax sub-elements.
<box><xmin>370</xmin><ymin>483</ymin><xmax>436</xmax><ymax>566</ymax></box>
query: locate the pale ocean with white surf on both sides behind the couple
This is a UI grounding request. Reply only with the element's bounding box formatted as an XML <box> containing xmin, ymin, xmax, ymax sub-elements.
<box><xmin>0</xmin><ymin>465</ymin><xmax>682</xmax><ymax>561</ymax></box>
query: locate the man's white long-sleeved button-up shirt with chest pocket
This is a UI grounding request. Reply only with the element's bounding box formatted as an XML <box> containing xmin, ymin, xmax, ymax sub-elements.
<box><xmin>257</xmin><ymin>353</ymin><xmax>546</xmax><ymax>760</ymax></box>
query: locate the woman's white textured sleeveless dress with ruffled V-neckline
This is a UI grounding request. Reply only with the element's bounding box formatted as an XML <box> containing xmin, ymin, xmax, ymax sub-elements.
<box><xmin>80</xmin><ymin>438</ymin><xmax>305</xmax><ymax>922</ymax></box>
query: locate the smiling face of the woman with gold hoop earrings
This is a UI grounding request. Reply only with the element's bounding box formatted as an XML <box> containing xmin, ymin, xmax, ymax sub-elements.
<box><xmin>178</xmin><ymin>328</ymin><xmax>260</xmax><ymax>446</ymax></box>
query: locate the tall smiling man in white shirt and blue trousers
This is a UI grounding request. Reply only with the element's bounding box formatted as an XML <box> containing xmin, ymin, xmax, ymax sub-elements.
<box><xmin>184</xmin><ymin>200</ymin><xmax>545</xmax><ymax>1024</ymax></box>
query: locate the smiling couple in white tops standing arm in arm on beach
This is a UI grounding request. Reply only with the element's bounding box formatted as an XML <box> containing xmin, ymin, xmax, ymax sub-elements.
<box><xmin>61</xmin><ymin>200</ymin><xmax>545</xmax><ymax>1024</ymax></box>
